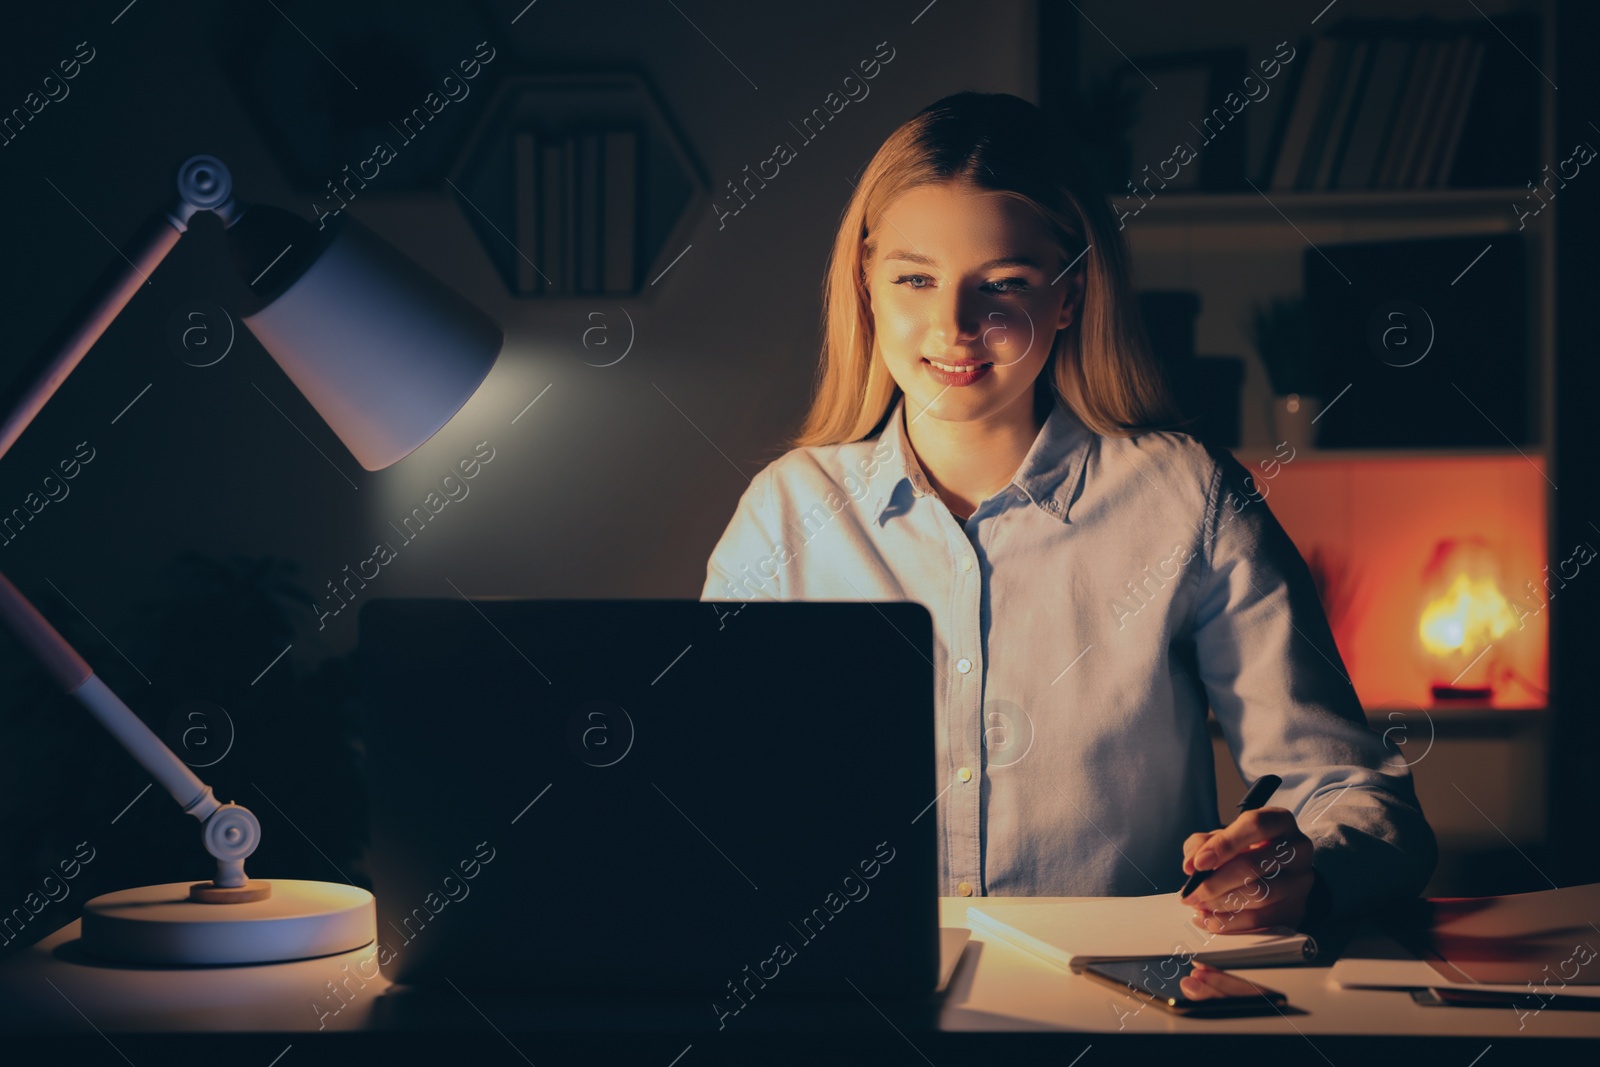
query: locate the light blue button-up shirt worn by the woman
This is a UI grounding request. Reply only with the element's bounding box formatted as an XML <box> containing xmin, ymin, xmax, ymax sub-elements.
<box><xmin>701</xmin><ymin>391</ymin><xmax>1437</xmax><ymax>913</ymax></box>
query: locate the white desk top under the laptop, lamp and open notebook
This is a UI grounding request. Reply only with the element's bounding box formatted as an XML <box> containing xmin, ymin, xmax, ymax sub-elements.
<box><xmin>0</xmin><ymin>897</ymin><xmax>1600</xmax><ymax>1045</ymax></box>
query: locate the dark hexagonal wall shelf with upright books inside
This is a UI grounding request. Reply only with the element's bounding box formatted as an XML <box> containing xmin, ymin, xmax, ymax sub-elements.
<box><xmin>451</xmin><ymin>72</ymin><xmax>710</xmax><ymax>298</ymax></box>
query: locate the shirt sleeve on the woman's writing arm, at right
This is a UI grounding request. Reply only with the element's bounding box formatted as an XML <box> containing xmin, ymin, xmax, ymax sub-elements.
<box><xmin>1194</xmin><ymin>453</ymin><xmax>1438</xmax><ymax>917</ymax></box>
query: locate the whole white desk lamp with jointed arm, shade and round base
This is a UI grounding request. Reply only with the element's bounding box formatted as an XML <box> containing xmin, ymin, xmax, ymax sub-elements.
<box><xmin>0</xmin><ymin>155</ymin><xmax>504</xmax><ymax>965</ymax></box>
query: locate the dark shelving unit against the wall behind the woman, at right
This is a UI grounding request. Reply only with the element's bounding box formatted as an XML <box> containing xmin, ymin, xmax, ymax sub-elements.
<box><xmin>1040</xmin><ymin>0</ymin><xmax>1565</xmax><ymax>870</ymax></box>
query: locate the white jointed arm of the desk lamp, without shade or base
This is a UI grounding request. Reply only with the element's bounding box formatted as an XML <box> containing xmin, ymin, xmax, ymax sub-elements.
<box><xmin>0</xmin><ymin>155</ymin><xmax>261</xmax><ymax>886</ymax></box>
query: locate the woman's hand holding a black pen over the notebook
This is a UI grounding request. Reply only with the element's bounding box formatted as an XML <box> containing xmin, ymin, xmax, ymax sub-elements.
<box><xmin>1184</xmin><ymin>808</ymin><xmax>1317</xmax><ymax>934</ymax></box>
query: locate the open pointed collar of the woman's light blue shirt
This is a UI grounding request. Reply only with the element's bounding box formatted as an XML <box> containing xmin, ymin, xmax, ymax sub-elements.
<box><xmin>874</xmin><ymin>394</ymin><xmax>1093</xmax><ymax>525</ymax></box>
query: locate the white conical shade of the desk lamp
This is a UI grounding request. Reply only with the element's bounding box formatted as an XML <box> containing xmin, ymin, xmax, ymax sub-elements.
<box><xmin>243</xmin><ymin>216</ymin><xmax>504</xmax><ymax>470</ymax></box>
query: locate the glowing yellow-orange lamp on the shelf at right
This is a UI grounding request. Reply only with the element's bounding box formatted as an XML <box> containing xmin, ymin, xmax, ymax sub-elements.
<box><xmin>1416</xmin><ymin>536</ymin><xmax>1520</xmax><ymax>701</ymax></box>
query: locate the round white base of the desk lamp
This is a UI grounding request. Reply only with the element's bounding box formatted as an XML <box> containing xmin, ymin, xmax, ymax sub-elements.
<box><xmin>83</xmin><ymin>878</ymin><xmax>378</xmax><ymax>966</ymax></box>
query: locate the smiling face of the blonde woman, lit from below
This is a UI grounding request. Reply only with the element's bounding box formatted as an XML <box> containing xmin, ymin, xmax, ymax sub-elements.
<box><xmin>867</xmin><ymin>182</ymin><xmax>1082</xmax><ymax>422</ymax></box>
